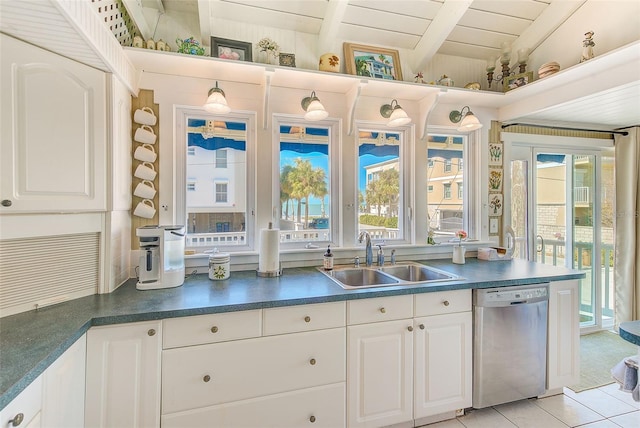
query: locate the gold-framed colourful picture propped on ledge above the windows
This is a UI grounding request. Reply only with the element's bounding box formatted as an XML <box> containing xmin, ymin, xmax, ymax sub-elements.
<box><xmin>344</xmin><ymin>43</ymin><xmax>402</xmax><ymax>80</ymax></box>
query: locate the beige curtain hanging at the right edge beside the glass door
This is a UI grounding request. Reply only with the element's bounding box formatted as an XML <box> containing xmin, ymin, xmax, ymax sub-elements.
<box><xmin>614</xmin><ymin>127</ymin><xmax>640</xmax><ymax>328</ymax></box>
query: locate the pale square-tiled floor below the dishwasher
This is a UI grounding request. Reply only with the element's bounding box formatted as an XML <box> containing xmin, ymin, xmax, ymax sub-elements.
<box><xmin>427</xmin><ymin>383</ymin><xmax>640</xmax><ymax>428</ymax></box>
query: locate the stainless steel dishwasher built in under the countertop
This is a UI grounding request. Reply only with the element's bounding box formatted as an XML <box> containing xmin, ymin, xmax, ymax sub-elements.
<box><xmin>473</xmin><ymin>284</ymin><xmax>549</xmax><ymax>409</ymax></box>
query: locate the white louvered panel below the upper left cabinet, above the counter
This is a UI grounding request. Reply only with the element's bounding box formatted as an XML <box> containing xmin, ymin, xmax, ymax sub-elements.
<box><xmin>0</xmin><ymin>233</ymin><xmax>100</xmax><ymax>316</ymax></box>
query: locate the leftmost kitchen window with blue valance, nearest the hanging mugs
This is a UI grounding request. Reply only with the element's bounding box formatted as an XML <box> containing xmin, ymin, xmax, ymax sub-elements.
<box><xmin>176</xmin><ymin>107</ymin><xmax>255</xmax><ymax>252</ymax></box>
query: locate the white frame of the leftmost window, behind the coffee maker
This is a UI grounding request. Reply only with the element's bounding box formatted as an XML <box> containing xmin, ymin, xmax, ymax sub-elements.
<box><xmin>174</xmin><ymin>105</ymin><xmax>257</xmax><ymax>253</ymax></box>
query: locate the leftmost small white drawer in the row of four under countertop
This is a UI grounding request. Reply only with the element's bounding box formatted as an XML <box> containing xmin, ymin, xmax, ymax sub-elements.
<box><xmin>162</xmin><ymin>309</ymin><xmax>262</xmax><ymax>349</ymax></box>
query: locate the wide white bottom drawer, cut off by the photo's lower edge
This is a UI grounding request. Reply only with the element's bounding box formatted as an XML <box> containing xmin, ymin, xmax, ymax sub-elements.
<box><xmin>162</xmin><ymin>382</ymin><xmax>346</xmax><ymax>428</ymax></box>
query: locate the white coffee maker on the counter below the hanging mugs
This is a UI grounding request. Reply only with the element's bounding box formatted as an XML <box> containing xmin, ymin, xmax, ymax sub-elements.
<box><xmin>136</xmin><ymin>225</ymin><xmax>184</xmax><ymax>290</ymax></box>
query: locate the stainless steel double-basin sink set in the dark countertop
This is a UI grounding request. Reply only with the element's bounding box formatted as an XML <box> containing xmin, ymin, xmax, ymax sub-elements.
<box><xmin>318</xmin><ymin>263</ymin><xmax>463</xmax><ymax>290</ymax></box>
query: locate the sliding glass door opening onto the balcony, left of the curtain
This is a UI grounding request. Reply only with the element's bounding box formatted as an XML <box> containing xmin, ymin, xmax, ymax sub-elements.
<box><xmin>506</xmin><ymin>144</ymin><xmax>615</xmax><ymax>328</ymax></box>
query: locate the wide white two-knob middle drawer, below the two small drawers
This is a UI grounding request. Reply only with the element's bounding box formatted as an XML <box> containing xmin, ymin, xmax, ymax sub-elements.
<box><xmin>162</xmin><ymin>328</ymin><xmax>346</xmax><ymax>414</ymax></box>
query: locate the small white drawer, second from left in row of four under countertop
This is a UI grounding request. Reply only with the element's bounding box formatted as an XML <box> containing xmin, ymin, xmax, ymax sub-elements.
<box><xmin>263</xmin><ymin>302</ymin><xmax>346</xmax><ymax>336</ymax></box>
